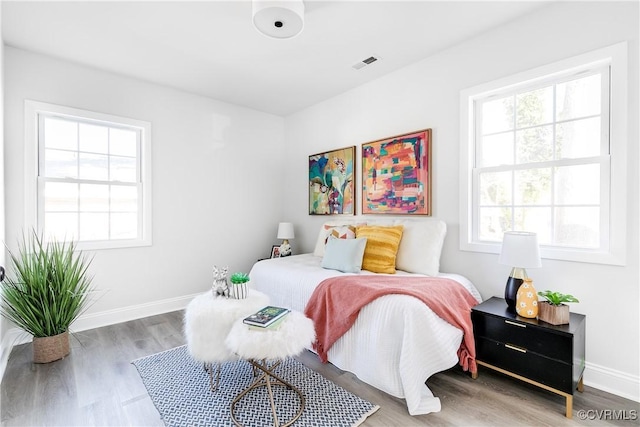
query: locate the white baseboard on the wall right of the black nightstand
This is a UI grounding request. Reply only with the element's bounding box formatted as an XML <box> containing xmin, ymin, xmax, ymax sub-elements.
<box><xmin>584</xmin><ymin>362</ymin><xmax>640</xmax><ymax>402</ymax></box>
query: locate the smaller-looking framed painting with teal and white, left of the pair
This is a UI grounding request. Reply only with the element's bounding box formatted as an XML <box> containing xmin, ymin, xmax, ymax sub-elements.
<box><xmin>309</xmin><ymin>146</ymin><xmax>356</xmax><ymax>215</ymax></box>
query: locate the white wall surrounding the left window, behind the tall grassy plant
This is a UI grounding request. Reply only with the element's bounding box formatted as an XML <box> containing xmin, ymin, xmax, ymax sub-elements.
<box><xmin>4</xmin><ymin>47</ymin><xmax>284</xmax><ymax>330</ymax></box>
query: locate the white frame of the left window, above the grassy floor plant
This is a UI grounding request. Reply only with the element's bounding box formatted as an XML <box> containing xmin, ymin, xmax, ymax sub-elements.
<box><xmin>24</xmin><ymin>100</ymin><xmax>152</xmax><ymax>250</ymax></box>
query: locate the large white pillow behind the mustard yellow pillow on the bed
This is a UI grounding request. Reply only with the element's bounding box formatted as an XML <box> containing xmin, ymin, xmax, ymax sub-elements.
<box><xmin>395</xmin><ymin>218</ymin><xmax>447</xmax><ymax>276</ymax></box>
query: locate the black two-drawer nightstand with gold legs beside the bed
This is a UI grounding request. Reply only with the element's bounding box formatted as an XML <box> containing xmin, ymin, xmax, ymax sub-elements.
<box><xmin>471</xmin><ymin>297</ymin><xmax>586</xmax><ymax>418</ymax></box>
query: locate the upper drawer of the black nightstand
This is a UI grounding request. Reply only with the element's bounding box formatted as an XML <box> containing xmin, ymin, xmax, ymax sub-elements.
<box><xmin>471</xmin><ymin>311</ymin><xmax>573</xmax><ymax>363</ymax></box>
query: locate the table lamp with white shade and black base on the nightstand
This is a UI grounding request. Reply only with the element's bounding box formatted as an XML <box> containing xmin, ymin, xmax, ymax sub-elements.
<box><xmin>498</xmin><ymin>231</ymin><xmax>542</xmax><ymax>313</ymax></box>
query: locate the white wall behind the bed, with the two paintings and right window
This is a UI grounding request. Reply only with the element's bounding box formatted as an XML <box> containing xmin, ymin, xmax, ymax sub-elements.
<box><xmin>285</xmin><ymin>2</ymin><xmax>640</xmax><ymax>400</ymax></box>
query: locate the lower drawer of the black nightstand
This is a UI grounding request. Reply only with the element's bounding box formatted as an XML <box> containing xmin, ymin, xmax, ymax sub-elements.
<box><xmin>476</xmin><ymin>336</ymin><xmax>577</xmax><ymax>394</ymax></box>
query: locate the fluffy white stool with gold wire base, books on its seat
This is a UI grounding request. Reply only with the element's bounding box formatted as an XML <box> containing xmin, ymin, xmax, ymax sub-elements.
<box><xmin>226</xmin><ymin>311</ymin><xmax>316</xmax><ymax>427</ymax></box>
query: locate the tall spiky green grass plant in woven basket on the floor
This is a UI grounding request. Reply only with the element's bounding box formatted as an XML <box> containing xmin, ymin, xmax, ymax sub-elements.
<box><xmin>0</xmin><ymin>231</ymin><xmax>92</xmax><ymax>363</ymax></box>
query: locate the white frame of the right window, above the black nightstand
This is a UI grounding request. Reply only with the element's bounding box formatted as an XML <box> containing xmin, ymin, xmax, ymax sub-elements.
<box><xmin>460</xmin><ymin>42</ymin><xmax>628</xmax><ymax>265</ymax></box>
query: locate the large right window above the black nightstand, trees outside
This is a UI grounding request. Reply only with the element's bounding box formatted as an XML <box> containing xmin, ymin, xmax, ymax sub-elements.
<box><xmin>461</xmin><ymin>45</ymin><xmax>626</xmax><ymax>264</ymax></box>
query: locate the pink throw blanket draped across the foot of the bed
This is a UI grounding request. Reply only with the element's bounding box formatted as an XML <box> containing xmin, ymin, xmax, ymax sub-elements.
<box><xmin>304</xmin><ymin>275</ymin><xmax>478</xmax><ymax>372</ymax></box>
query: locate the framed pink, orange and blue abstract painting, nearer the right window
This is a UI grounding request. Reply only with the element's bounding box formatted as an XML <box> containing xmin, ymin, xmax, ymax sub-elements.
<box><xmin>362</xmin><ymin>129</ymin><xmax>432</xmax><ymax>215</ymax></box>
